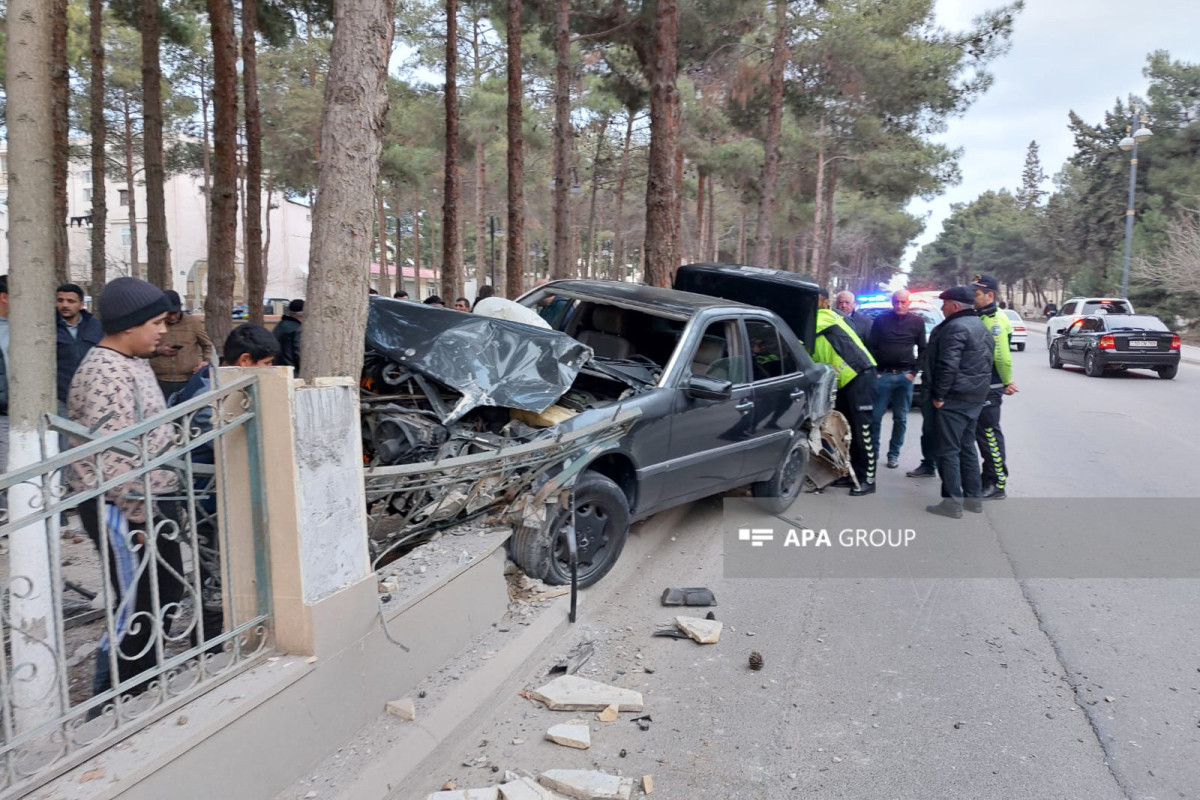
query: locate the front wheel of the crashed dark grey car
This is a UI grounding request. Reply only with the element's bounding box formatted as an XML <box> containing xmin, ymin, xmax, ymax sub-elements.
<box><xmin>535</xmin><ymin>471</ymin><xmax>631</xmax><ymax>589</ymax></box>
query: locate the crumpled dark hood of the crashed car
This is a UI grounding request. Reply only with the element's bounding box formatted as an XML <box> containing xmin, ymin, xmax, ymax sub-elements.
<box><xmin>366</xmin><ymin>297</ymin><xmax>592</xmax><ymax>423</ymax></box>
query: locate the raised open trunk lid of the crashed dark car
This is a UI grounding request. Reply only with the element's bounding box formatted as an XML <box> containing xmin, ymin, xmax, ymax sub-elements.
<box><xmin>674</xmin><ymin>264</ymin><xmax>821</xmax><ymax>353</ymax></box>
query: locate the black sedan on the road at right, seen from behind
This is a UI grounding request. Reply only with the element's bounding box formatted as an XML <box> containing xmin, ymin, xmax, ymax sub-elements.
<box><xmin>1050</xmin><ymin>314</ymin><xmax>1180</xmax><ymax>380</ymax></box>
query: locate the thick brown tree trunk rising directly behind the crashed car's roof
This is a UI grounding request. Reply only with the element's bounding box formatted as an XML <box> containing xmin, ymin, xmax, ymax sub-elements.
<box><xmin>643</xmin><ymin>0</ymin><xmax>679</xmax><ymax>287</ymax></box>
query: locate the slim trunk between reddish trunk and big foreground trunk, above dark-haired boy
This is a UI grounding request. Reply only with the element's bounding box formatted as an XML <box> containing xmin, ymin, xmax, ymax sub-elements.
<box><xmin>241</xmin><ymin>0</ymin><xmax>266</xmax><ymax>325</ymax></box>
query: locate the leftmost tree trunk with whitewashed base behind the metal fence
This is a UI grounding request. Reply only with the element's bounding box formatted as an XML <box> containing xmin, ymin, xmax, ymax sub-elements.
<box><xmin>4</xmin><ymin>0</ymin><xmax>66</xmax><ymax>739</ymax></box>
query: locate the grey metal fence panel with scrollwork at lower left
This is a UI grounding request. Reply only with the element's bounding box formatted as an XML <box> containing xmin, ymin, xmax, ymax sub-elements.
<box><xmin>0</xmin><ymin>375</ymin><xmax>271</xmax><ymax>798</ymax></box>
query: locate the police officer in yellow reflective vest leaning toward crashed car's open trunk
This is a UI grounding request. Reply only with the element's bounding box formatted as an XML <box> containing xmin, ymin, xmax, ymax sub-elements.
<box><xmin>812</xmin><ymin>289</ymin><xmax>876</xmax><ymax>498</ymax></box>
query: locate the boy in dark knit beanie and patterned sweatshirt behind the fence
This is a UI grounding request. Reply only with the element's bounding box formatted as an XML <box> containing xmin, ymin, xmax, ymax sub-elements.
<box><xmin>67</xmin><ymin>278</ymin><xmax>188</xmax><ymax>693</ymax></box>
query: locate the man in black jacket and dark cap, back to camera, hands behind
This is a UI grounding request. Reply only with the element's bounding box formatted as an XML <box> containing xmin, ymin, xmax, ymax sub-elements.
<box><xmin>925</xmin><ymin>287</ymin><xmax>995</xmax><ymax>519</ymax></box>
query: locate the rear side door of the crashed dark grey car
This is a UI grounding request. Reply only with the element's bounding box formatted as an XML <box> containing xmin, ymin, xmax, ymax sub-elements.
<box><xmin>743</xmin><ymin>317</ymin><xmax>810</xmax><ymax>476</ymax></box>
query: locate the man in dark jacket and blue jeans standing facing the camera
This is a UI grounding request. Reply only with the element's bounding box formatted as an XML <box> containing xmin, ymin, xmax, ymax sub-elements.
<box><xmin>866</xmin><ymin>289</ymin><xmax>925</xmax><ymax>469</ymax></box>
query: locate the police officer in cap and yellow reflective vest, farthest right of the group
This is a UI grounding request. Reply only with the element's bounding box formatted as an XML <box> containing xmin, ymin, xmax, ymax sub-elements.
<box><xmin>971</xmin><ymin>275</ymin><xmax>1016</xmax><ymax>500</ymax></box>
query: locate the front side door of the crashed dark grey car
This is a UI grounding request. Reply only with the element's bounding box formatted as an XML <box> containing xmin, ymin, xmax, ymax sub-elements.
<box><xmin>660</xmin><ymin>318</ymin><xmax>755</xmax><ymax>499</ymax></box>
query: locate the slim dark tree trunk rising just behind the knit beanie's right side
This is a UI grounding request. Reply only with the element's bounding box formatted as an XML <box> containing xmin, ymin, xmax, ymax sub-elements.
<box><xmin>142</xmin><ymin>0</ymin><xmax>170</xmax><ymax>287</ymax></box>
